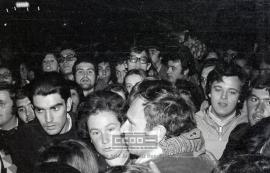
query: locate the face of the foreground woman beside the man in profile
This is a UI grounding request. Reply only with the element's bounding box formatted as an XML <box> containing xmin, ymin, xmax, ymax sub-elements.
<box><xmin>87</xmin><ymin>111</ymin><xmax>124</xmax><ymax>160</ymax></box>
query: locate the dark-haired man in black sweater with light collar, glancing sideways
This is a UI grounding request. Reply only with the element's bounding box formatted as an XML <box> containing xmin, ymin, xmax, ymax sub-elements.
<box><xmin>8</xmin><ymin>72</ymin><xmax>77</xmax><ymax>172</ymax></box>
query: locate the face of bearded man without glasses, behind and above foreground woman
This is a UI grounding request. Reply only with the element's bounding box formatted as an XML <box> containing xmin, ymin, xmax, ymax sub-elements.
<box><xmin>75</xmin><ymin>62</ymin><xmax>96</xmax><ymax>90</ymax></box>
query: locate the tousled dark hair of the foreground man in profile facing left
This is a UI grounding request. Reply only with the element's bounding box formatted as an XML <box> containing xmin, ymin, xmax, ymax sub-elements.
<box><xmin>130</xmin><ymin>80</ymin><xmax>195</xmax><ymax>137</ymax></box>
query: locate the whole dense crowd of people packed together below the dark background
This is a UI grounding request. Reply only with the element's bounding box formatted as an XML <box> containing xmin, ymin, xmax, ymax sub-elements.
<box><xmin>0</xmin><ymin>31</ymin><xmax>270</xmax><ymax>173</ymax></box>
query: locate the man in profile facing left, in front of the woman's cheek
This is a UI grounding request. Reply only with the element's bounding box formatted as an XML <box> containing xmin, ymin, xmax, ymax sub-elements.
<box><xmin>121</xmin><ymin>80</ymin><xmax>213</xmax><ymax>173</ymax></box>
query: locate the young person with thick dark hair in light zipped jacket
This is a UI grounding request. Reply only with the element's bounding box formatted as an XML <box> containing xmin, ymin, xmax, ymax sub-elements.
<box><xmin>195</xmin><ymin>63</ymin><xmax>247</xmax><ymax>159</ymax></box>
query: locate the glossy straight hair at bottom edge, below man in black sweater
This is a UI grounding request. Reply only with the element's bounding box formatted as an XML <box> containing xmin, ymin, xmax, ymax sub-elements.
<box><xmin>37</xmin><ymin>139</ymin><xmax>98</xmax><ymax>173</ymax></box>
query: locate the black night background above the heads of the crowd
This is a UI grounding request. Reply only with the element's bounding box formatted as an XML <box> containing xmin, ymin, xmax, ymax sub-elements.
<box><xmin>0</xmin><ymin>0</ymin><xmax>270</xmax><ymax>55</ymax></box>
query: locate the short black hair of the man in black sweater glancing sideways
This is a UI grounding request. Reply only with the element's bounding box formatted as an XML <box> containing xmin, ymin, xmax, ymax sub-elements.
<box><xmin>31</xmin><ymin>72</ymin><xmax>70</xmax><ymax>101</ymax></box>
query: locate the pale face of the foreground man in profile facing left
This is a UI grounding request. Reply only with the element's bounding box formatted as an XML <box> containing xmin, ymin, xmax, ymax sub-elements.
<box><xmin>121</xmin><ymin>97</ymin><xmax>147</xmax><ymax>156</ymax></box>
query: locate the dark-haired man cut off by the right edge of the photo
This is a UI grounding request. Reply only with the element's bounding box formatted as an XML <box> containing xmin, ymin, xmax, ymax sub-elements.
<box><xmin>222</xmin><ymin>75</ymin><xmax>270</xmax><ymax>159</ymax></box>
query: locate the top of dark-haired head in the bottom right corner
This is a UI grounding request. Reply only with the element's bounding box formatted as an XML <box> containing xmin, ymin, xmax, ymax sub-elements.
<box><xmin>215</xmin><ymin>154</ymin><xmax>270</xmax><ymax>173</ymax></box>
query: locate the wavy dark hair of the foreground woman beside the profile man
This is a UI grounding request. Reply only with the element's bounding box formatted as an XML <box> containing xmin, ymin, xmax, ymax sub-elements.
<box><xmin>78</xmin><ymin>91</ymin><xmax>125</xmax><ymax>138</ymax></box>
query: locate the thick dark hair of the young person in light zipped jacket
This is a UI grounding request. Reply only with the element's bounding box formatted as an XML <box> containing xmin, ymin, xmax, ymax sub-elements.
<box><xmin>205</xmin><ymin>62</ymin><xmax>248</xmax><ymax>111</ymax></box>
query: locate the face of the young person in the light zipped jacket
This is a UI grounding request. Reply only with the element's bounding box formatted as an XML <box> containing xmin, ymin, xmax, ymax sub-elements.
<box><xmin>209</xmin><ymin>76</ymin><xmax>241</xmax><ymax>118</ymax></box>
